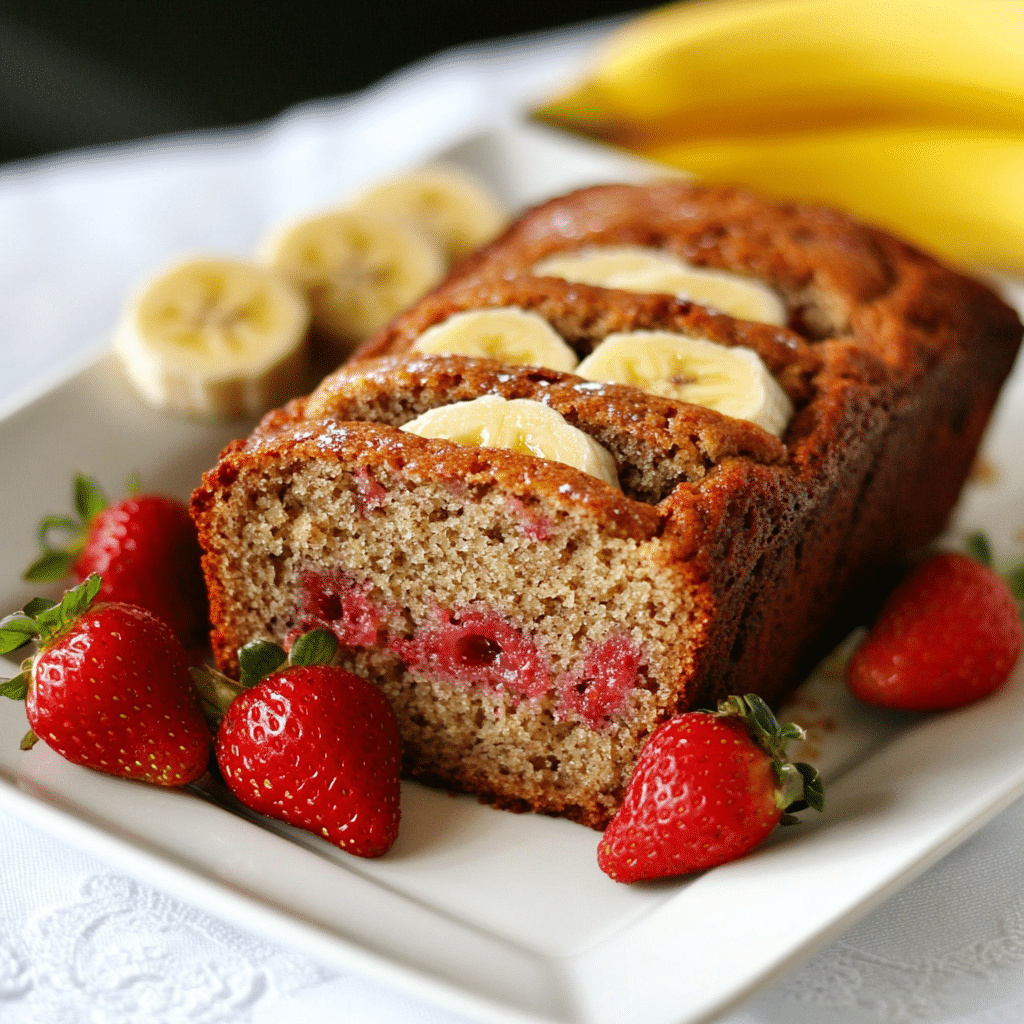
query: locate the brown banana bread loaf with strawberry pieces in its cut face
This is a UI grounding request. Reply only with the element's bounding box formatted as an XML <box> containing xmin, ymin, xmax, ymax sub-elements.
<box><xmin>193</xmin><ymin>183</ymin><xmax>1021</xmax><ymax>827</ymax></box>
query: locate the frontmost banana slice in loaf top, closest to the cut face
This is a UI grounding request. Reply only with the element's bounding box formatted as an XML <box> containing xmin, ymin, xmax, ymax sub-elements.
<box><xmin>401</xmin><ymin>394</ymin><xmax>618</xmax><ymax>487</ymax></box>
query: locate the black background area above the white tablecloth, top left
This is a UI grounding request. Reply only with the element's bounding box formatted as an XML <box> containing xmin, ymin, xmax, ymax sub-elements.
<box><xmin>0</xmin><ymin>0</ymin><xmax>649</xmax><ymax>161</ymax></box>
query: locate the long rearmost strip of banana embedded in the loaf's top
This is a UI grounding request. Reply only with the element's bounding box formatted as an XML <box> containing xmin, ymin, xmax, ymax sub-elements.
<box><xmin>530</xmin><ymin>246</ymin><xmax>788</xmax><ymax>327</ymax></box>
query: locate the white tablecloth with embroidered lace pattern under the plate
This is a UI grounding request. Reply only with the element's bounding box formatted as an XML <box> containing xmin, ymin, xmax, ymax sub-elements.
<box><xmin>6</xmin><ymin>18</ymin><xmax>1024</xmax><ymax>1024</ymax></box>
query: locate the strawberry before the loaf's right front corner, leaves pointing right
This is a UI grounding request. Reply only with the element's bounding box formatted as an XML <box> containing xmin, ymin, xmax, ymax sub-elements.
<box><xmin>597</xmin><ymin>694</ymin><xmax>824</xmax><ymax>882</ymax></box>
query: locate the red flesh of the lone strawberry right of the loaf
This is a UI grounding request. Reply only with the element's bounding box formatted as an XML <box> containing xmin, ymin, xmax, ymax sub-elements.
<box><xmin>847</xmin><ymin>553</ymin><xmax>1021</xmax><ymax>711</ymax></box>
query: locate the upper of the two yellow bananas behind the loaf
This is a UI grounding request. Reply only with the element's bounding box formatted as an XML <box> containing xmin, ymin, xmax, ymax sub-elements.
<box><xmin>546</xmin><ymin>0</ymin><xmax>1024</xmax><ymax>138</ymax></box>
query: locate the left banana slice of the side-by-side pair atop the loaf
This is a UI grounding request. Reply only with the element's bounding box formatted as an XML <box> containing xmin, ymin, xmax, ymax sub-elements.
<box><xmin>413</xmin><ymin>306</ymin><xmax>580</xmax><ymax>373</ymax></box>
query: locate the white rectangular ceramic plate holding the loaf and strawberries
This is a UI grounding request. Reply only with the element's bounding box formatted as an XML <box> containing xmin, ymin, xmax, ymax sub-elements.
<box><xmin>0</xmin><ymin>126</ymin><xmax>1024</xmax><ymax>1024</ymax></box>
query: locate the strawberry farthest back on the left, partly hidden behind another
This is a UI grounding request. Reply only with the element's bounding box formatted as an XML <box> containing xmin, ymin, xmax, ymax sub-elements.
<box><xmin>25</xmin><ymin>474</ymin><xmax>208</xmax><ymax>647</ymax></box>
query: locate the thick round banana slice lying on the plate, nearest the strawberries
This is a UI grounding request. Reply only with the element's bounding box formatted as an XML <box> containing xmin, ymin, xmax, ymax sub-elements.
<box><xmin>115</xmin><ymin>259</ymin><xmax>309</xmax><ymax>418</ymax></box>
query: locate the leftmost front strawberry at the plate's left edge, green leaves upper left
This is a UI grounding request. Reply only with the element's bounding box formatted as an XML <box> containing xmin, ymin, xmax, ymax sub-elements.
<box><xmin>0</xmin><ymin>575</ymin><xmax>211</xmax><ymax>785</ymax></box>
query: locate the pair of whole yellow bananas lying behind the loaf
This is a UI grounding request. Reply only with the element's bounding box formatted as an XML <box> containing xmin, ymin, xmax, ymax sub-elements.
<box><xmin>537</xmin><ymin>0</ymin><xmax>1024</xmax><ymax>270</ymax></box>
